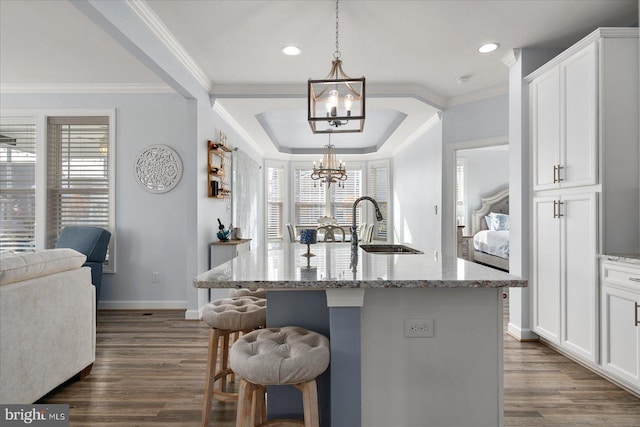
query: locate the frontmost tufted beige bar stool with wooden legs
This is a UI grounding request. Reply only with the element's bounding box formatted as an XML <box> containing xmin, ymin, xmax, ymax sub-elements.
<box><xmin>230</xmin><ymin>326</ymin><xmax>330</xmax><ymax>427</ymax></box>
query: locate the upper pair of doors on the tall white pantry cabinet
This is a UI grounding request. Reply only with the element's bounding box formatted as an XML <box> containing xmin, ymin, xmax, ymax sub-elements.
<box><xmin>530</xmin><ymin>42</ymin><xmax>598</xmax><ymax>191</ymax></box>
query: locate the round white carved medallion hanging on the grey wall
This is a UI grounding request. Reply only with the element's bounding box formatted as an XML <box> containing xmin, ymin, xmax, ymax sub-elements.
<box><xmin>133</xmin><ymin>144</ymin><xmax>182</xmax><ymax>193</ymax></box>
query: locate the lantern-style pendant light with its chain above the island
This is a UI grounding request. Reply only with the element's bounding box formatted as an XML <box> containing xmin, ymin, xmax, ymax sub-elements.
<box><xmin>307</xmin><ymin>0</ymin><xmax>365</xmax><ymax>133</ymax></box>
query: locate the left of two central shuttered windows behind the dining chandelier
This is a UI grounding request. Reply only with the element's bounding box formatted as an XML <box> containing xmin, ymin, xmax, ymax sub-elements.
<box><xmin>293</xmin><ymin>169</ymin><xmax>325</xmax><ymax>228</ymax></box>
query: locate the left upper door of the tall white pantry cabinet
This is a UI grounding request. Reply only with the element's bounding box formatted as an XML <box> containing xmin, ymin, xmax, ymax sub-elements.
<box><xmin>529</xmin><ymin>67</ymin><xmax>560</xmax><ymax>190</ymax></box>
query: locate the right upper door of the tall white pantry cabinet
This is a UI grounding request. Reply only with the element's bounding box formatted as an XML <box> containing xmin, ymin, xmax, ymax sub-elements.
<box><xmin>559</xmin><ymin>43</ymin><xmax>598</xmax><ymax>187</ymax></box>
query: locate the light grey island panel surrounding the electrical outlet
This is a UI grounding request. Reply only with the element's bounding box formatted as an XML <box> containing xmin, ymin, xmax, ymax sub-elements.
<box><xmin>361</xmin><ymin>288</ymin><xmax>503</xmax><ymax>427</ymax></box>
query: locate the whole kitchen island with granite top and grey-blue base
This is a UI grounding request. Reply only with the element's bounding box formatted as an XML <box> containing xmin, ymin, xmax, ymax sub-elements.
<box><xmin>194</xmin><ymin>243</ymin><xmax>527</xmax><ymax>427</ymax></box>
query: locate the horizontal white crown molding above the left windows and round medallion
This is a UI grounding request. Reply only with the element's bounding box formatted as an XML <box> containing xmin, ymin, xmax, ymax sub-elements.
<box><xmin>0</xmin><ymin>83</ymin><xmax>175</xmax><ymax>94</ymax></box>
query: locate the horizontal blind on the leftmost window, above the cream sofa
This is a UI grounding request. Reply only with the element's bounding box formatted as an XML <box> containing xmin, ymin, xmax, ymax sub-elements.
<box><xmin>0</xmin><ymin>117</ymin><xmax>36</xmax><ymax>252</ymax></box>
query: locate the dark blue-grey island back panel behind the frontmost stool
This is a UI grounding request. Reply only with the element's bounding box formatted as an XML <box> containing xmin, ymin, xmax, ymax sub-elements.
<box><xmin>267</xmin><ymin>291</ymin><xmax>331</xmax><ymax>427</ymax></box>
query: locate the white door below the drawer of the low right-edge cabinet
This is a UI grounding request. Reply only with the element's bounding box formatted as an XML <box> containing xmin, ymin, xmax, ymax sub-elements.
<box><xmin>602</xmin><ymin>282</ymin><xmax>640</xmax><ymax>386</ymax></box>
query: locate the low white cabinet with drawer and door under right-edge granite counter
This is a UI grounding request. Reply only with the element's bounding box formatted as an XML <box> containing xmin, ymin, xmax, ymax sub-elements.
<box><xmin>601</xmin><ymin>261</ymin><xmax>640</xmax><ymax>392</ymax></box>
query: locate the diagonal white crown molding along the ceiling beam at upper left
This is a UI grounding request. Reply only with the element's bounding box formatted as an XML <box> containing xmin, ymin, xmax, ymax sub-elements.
<box><xmin>126</xmin><ymin>0</ymin><xmax>213</xmax><ymax>92</ymax></box>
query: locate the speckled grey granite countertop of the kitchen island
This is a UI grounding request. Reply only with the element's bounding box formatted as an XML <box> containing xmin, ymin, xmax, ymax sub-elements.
<box><xmin>193</xmin><ymin>242</ymin><xmax>527</xmax><ymax>289</ymax></box>
